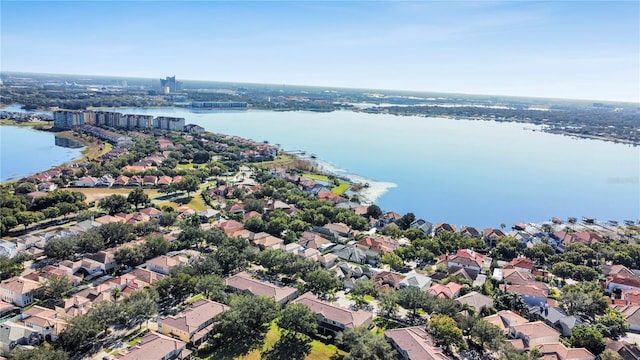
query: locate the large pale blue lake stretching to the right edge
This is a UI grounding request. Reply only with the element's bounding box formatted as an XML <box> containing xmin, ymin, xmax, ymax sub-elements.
<box><xmin>109</xmin><ymin>108</ymin><xmax>640</xmax><ymax>228</ymax></box>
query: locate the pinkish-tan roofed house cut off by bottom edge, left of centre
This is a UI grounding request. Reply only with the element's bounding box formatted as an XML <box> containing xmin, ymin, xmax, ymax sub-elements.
<box><xmin>116</xmin><ymin>332</ymin><xmax>191</xmax><ymax>360</ymax></box>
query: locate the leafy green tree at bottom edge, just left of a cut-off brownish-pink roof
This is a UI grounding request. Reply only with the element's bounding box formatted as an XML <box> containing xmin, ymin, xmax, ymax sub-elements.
<box><xmin>336</xmin><ymin>326</ymin><xmax>396</xmax><ymax>360</ymax></box>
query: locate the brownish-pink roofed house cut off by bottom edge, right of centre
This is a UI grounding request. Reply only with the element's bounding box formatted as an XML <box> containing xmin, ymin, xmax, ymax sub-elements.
<box><xmin>384</xmin><ymin>326</ymin><xmax>450</xmax><ymax>360</ymax></box>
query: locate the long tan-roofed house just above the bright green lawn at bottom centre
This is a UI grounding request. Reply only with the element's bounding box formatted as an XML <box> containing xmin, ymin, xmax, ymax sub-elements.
<box><xmin>292</xmin><ymin>292</ymin><xmax>373</xmax><ymax>334</ymax></box>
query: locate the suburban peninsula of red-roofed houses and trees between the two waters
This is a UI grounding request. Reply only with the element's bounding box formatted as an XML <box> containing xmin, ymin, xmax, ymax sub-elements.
<box><xmin>0</xmin><ymin>116</ymin><xmax>640</xmax><ymax>360</ymax></box>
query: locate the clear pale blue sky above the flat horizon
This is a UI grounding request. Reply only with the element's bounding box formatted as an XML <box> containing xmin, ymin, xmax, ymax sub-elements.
<box><xmin>0</xmin><ymin>0</ymin><xmax>640</xmax><ymax>102</ymax></box>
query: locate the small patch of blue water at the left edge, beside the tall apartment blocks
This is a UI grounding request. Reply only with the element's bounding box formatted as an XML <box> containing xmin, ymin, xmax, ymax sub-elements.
<box><xmin>0</xmin><ymin>127</ymin><xmax>83</xmax><ymax>181</ymax></box>
